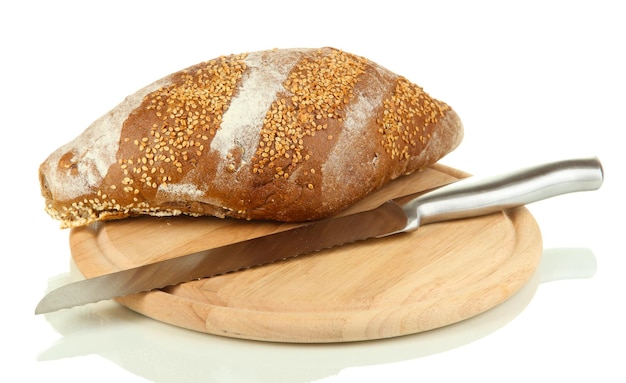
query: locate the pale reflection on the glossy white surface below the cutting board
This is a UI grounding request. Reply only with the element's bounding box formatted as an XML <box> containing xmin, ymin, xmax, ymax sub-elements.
<box><xmin>38</xmin><ymin>248</ymin><xmax>596</xmax><ymax>382</ymax></box>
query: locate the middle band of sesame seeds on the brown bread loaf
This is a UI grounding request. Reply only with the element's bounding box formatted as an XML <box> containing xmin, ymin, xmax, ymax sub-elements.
<box><xmin>252</xmin><ymin>49</ymin><xmax>367</xmax><ymax>176</ymax></box>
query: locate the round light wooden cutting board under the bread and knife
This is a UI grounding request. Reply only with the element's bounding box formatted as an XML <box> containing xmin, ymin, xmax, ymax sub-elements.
<box><xmin>70</xmin><ymin>165</ymin><xmax>542</xmax><ymax>343</ymax></box>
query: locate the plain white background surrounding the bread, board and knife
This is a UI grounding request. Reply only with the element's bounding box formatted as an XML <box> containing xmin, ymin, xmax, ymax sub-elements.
<box><xmin>0</xmin><ymin>0</ymin><xmax>626</xmax><ymax>382</ymax></box>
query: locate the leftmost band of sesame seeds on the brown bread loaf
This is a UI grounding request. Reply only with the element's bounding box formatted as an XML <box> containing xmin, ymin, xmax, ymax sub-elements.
<box><xmin>109</xmin><ymin>54</ymin><xmax>247</xmax><ymax>207</ymax></box>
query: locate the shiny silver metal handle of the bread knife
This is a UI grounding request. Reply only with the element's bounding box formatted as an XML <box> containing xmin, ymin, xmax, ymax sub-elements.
<box><xmin>402</xmin><ymin>157</ymin><xmax>604</xmax><ymax>231</ymax></box>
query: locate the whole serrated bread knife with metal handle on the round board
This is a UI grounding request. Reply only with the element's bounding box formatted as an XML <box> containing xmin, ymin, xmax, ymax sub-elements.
<box><xmin>35</xmin><ymin>157</ymin><xmax>604</xmax><ymax>314</ymax></box>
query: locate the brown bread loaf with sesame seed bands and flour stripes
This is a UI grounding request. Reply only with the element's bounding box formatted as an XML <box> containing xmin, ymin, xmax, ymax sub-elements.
<box><xmin>40</xmin><ymin>48</ymin><xmax>463</xmax><ymax>227</ymax></box>
